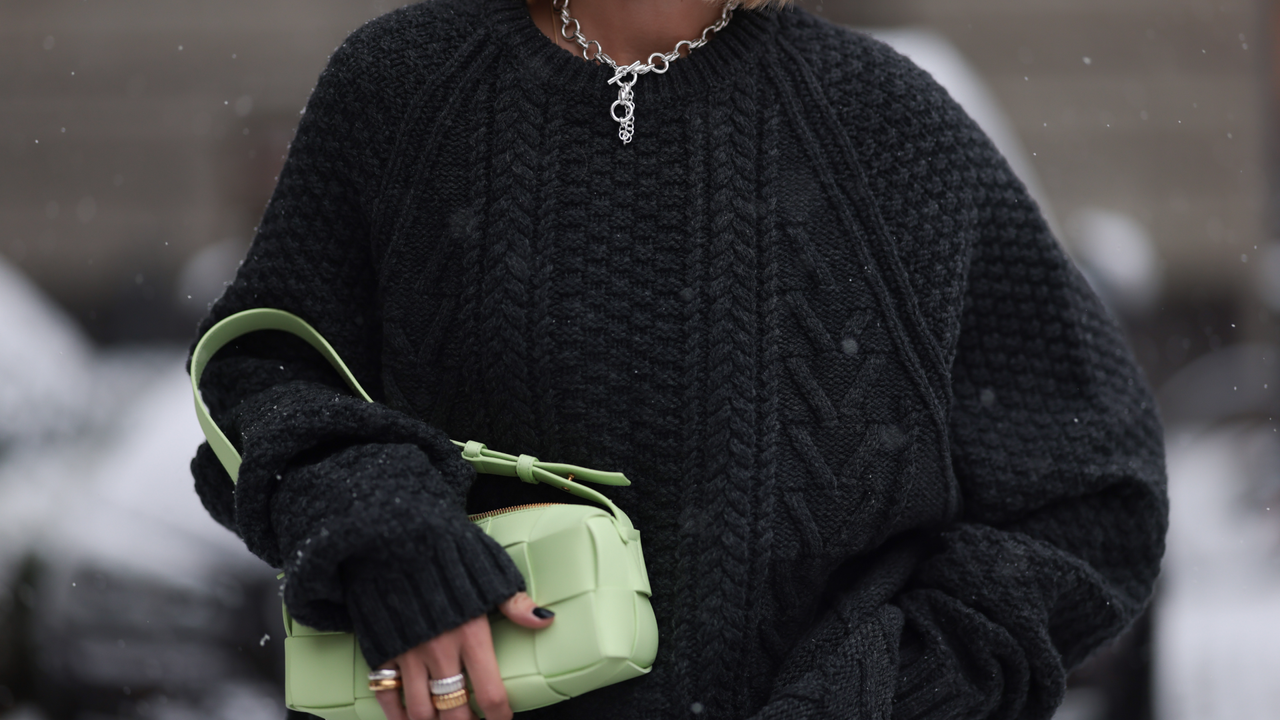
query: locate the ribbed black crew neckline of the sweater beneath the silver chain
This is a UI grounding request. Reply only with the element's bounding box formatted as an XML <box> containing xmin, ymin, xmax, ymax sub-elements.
<box><xmin>485</xmin><ymin>0</ymin><xmax>776</xmax><ymax>101</ymax></box>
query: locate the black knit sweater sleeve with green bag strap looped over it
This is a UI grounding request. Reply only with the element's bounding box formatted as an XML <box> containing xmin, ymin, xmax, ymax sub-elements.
<box><xmin>192</xmin><ymin>18</ymin><xmax>524</xmax><ymax>666</ymax></box>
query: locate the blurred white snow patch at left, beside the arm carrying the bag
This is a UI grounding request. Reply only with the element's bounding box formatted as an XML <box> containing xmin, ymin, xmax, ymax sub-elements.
<box><xmin>0</xmin><ymin>249</ymin><xmax>262</xmax><ymax>584</ymax></box>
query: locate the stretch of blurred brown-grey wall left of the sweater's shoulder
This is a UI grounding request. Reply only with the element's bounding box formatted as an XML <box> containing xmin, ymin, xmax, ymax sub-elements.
<box><xmin>0</xmin><ymin>0</ymin><xmax>403</xmax><ymax>341</ymax></box>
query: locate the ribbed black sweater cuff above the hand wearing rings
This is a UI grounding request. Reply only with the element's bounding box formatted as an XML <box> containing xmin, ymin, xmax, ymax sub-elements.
<box><xmin>343</xmin><ymin>524</ymin><xmax>525</xmax><ymax>667</ymax></box>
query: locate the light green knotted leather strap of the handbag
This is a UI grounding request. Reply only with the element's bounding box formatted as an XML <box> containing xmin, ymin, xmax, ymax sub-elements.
<box><xmin>191</xmin><ymin>307</ymin><xmax>640</xmax><ymax>539</ymax></box>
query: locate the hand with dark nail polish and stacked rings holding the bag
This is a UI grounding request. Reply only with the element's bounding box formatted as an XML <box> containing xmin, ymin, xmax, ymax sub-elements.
<box><xmin>376</xmin><ymin>592</ymin><xmax>552</xmax><ymax>720</ymax></box>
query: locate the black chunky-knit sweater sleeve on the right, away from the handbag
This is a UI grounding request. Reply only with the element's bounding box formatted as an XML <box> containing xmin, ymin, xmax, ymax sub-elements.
<box><xmin>754</xmin><ymin>23</ymin><xmax>1167</xmax><ymax>720</ymax></box>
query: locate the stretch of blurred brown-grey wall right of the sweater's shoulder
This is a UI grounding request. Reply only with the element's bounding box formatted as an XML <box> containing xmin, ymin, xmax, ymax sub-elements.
<box><xmin>804</xmin><ymin>0</ymin><xmax>1270</xmax><ymax>293</ymax></box>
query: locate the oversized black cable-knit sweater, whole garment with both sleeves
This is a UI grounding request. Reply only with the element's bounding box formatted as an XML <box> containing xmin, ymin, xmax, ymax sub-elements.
<box><xmin>193</xmin><ymin>0</ymin><xmax>1167</xmax><ymax>720</ymax></box>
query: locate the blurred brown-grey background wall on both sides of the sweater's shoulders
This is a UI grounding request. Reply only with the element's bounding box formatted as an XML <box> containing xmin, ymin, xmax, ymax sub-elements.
<box><xmin>0</xmin><ymin>0</ymin><xmax>1270</xmax><ymax>342</ymax></box>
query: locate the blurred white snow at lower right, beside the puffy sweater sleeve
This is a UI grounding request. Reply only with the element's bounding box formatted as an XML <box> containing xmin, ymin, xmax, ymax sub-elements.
<box><xmin>1155</xmin><ymin>427</ymin><xmax>1280</xmax><ymax>720</ymax></box>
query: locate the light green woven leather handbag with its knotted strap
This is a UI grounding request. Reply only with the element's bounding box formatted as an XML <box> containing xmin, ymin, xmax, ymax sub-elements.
<box><xmin>191</xmin><ymin>307</ymin><xmax>658</xmax><ymax>720</ymax></box>
